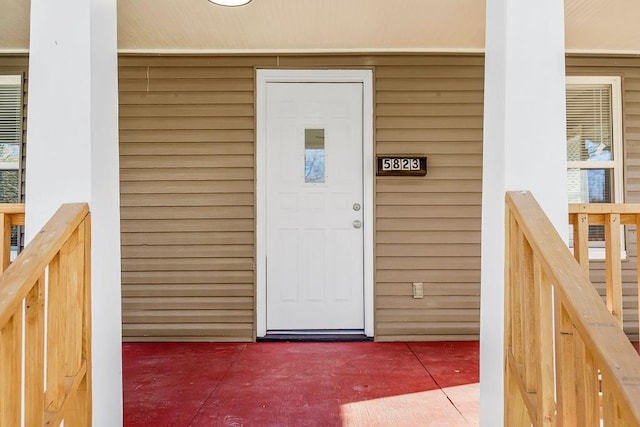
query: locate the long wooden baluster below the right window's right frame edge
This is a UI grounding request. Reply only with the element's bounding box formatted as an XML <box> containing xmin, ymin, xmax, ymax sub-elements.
<box><xmin>604</xmin><ymin>213</ymin><xmax>623</xmax><ymax>327</ymax></box>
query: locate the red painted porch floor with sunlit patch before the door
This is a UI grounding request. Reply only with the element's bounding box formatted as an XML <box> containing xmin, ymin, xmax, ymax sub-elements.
<box><xmin>123</xmin><ymin>342</ymin><xmax>479</xmax><ymax>427</ymax></box>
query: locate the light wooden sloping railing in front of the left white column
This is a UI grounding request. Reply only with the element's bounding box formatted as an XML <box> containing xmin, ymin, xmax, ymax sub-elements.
<box><xmin>0</xmin><ymin>204</ymin><xmax>91</xmax><ymax>426</ymax></box>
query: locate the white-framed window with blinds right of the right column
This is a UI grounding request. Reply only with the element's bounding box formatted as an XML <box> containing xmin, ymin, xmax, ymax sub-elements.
<box><xmin>566</xmin><ymin>77</ymin><xmax>623</xmax><ymax>247</ymax></box>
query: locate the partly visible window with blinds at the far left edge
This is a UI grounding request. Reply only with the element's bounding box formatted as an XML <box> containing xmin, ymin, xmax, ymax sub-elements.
<box><xmin>0</xmin><ymin>75</ymin><xmax>22</xmax><ymax>247</ymax></box>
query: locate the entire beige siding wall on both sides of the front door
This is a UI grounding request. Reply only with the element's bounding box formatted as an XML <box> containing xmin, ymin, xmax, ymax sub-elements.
<box><xmin>120</xmin><ymin>55</ymin><xmax>484</xmax><ymax>341</ymax></box>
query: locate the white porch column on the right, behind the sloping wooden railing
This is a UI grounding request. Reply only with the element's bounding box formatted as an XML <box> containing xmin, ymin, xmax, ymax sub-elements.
<box><xmin>480</xmin><ymin>0</ymin><xmax>568</xmax><ymax>427</ymax></box>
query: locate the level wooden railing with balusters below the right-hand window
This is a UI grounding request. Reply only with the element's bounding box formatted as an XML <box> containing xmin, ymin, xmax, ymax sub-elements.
<box><xmin>569</xmin><ymin>203</ymin><xmax>640</xmax><ymax>334</ymax></box>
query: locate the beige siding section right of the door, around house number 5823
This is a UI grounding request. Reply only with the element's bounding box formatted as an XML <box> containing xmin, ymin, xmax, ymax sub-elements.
<box><xmin>375</xmin><ymin>57</ymin><xmax>484</xmax><ymax>341</ymax></box>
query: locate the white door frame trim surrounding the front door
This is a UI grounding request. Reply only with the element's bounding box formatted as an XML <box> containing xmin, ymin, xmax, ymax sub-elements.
<box><xmin>256</xmin><ymin>69</ymin><xmax>374</xmax><ymax>337</ymax></box>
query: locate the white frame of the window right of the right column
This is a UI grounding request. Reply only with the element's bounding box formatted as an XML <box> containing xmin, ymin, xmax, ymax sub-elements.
<box><xmin>565</xmin><ymin>76</ymin><xmax>627</xmax><ymax>260</ymax></box>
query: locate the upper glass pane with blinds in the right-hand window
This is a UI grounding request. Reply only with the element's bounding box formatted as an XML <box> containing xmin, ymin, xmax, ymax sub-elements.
<box><xmin>567</xmin><ymin>84</ymin><xmax>617</xmax><ymax>161</ymax></box>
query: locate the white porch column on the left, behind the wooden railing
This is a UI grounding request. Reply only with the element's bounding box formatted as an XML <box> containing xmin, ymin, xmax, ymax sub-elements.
<box><xmin>26</xmin><ymin>0</ymin><xmax>122</xmax><ymax>426</ymax></box>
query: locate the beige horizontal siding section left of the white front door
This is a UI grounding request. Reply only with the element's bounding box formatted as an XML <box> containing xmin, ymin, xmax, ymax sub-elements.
<box><xmin>119</xmin><ymin>56</ymin><xmax>255</xmax><ymax>341</ymax></box>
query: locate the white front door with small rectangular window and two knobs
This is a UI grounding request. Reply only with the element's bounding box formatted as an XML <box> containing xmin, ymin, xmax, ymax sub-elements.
<box><xmin>265</xmin><ymin>82</ymin><xmax>365</xmax><ymax>331</ymax></box>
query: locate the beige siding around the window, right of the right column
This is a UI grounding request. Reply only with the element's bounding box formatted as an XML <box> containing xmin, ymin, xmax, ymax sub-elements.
<box><xmin>566</xmin><ymin>55</ymin><xmax>640</xmax><ymax>341</ymax></box>
